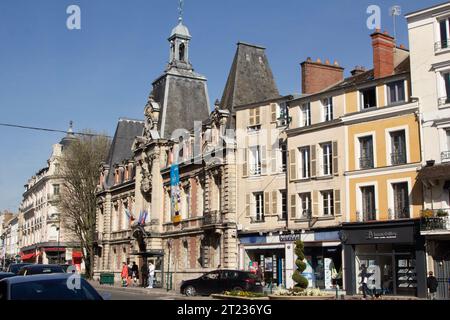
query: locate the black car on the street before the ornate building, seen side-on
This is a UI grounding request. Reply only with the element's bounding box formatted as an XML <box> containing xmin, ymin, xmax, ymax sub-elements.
<box><xmin>180</xmin><ymin>270</ymin><xmax>263</xmax><ymax>296</ymax></box>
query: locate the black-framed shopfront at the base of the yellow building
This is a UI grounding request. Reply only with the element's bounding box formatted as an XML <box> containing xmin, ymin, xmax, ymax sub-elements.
<box><xmin>340</xmin><ymin>220</ymin><xmax>427</xmax><ymax>298</ymax></box>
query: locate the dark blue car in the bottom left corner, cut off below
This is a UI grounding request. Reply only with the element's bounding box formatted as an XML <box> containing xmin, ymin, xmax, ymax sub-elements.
<box><xmin>0</xmin><ymin>273</ymin><xmax>103</xmax><ymax>301</ymax></box>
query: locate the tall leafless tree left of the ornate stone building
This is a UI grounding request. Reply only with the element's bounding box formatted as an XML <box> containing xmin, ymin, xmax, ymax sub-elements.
<box><xmin>58</xmin><ymin>132</ymin><xmax>110</xmax><ymax>278</ymax></box>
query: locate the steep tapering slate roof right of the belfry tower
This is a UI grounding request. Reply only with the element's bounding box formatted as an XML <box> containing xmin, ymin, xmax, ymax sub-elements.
<box><xmin>221</xmin><ymin>42</ymin><xmax>280</xmax><ymax>113</ymax></box>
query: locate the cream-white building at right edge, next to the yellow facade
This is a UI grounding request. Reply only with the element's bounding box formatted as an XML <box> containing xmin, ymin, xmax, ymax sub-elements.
<box><xmin>406</xmin><ymin>2</ymin><xmax>450</xmax><ymax>299</ymax></box>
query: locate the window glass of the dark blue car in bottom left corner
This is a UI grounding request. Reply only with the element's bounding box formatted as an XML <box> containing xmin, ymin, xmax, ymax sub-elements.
<box><xmin>11</xmin><ymin>278</ymin><xmax>101</xmax><ymax>300</ymax></box>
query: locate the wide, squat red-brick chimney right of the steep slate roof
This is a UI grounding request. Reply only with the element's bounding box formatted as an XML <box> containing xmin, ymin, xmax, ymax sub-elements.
<box><xmin>301</xmin><ymin>58</ymin><xmax>344</xmax><ymax>94</ymax></box>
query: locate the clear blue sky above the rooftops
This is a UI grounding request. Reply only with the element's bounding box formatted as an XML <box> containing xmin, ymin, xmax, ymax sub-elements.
<box><xmin>0</xmin><ymin>0</ymin><xmax>444</xmax><ymax>211</ymax></box>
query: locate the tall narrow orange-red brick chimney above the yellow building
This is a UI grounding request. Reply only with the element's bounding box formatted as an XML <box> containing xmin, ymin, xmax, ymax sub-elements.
<box><xmin>370</xmin><ymin>29</ymin><xmax>395</xmax><ymax>79</ymax></box>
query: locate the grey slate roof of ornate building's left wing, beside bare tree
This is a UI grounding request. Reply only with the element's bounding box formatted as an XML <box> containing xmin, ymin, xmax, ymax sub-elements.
<box><xmin>106</xmin><ymin>119</ymin><xmax>144</xmax><ymax>187</ymax></box>
